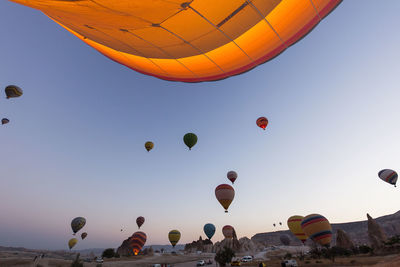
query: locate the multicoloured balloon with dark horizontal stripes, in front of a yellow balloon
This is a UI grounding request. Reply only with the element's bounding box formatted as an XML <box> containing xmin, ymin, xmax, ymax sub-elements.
<box><xmin>301</xmin><ymin>214</ymin><xmax>332</xmax><ymax>247</ymax></box>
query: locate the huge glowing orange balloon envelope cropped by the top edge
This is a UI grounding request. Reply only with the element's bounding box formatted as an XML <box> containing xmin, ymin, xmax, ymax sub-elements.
<box><xmin>12</xmin><ymin>0</ymin><xmax>341</xmax><ymax>82</ymax></box>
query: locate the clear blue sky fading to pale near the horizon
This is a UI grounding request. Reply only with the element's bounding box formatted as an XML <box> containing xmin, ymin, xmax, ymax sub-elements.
<box><xmin>0</xmin><ymin>0</ymin><xmax>400</xmax><ymax>249</ymax></box>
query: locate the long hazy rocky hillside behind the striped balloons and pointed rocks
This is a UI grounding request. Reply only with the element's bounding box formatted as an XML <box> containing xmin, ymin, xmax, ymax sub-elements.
<box><xmin>251</xmin><ymin>211</ymin><xmax>400</xmax><ymax>246</ymax></box>
